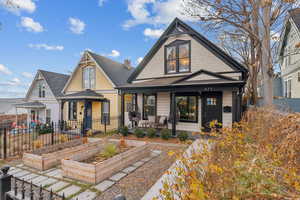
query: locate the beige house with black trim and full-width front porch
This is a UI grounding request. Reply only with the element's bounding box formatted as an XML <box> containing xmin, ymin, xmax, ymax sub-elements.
<box><xmin>117</xmin><ymin>18</ymin><xmax>247</xmax><ymax>134</ymax></box>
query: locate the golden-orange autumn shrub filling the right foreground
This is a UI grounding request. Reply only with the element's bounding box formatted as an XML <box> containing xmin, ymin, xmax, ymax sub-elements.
<box><xmin>160</xmin><ymin>108</ymin><xmax>300</xmax><ymax>200</ymax></box>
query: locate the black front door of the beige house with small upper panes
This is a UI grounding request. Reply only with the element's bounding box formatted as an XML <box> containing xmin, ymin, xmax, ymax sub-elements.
<box><xmin>202</xmin><ymin>92</ymin><xmax>222</xmax><ymax>131</ymax></box>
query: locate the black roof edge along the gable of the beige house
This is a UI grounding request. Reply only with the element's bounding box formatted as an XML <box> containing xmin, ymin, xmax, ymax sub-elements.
<box><xmin>128</xmin><ymin>18</ymin><xmax>248</xmax><ymax>82</ymax></box>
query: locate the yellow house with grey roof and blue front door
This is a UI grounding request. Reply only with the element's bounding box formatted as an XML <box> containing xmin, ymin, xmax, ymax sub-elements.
<box><xmin>60</xmin><ymin>51</ymin><xmax>133</xmax><ymax>131</ymax></box>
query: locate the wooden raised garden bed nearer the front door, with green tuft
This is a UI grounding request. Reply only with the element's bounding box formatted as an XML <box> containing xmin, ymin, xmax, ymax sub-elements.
<box><xmin>61</xmin><ymin>139</ymin><xmax>150</xmax><ymax>184</ymax></box>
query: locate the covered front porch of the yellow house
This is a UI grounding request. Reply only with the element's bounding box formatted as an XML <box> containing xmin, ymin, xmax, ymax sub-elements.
<box><xmin>60</xmin><ymin>90</ymin><xmax>110</xmax><ymax>133</ymax></box>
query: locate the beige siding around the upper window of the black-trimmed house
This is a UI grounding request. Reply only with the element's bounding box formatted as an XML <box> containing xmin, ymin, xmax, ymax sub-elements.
<box><xmin>136</xmin><ymin>34</ymin><xmax>241</xmax><ymax>80</ymax></box>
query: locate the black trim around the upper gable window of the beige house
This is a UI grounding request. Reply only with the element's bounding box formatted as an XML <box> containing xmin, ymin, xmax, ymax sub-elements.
<box><xmin>164</xmin><ymin>40</ymin><xmax>192</xmax><ymax>75</ymax></box>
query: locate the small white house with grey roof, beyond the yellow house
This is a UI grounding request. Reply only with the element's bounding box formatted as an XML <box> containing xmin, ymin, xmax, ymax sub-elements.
<box><xmin>16</xmin><ymin>70</ymin><xmax>69</xmax><ymax>123</ymax></box>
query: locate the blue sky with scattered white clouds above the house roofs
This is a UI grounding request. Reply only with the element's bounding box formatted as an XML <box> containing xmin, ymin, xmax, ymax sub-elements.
<box><xmin>0</xmin><ymin>0</ymin><xmax>207</xmax><ymax>98</ymax></box>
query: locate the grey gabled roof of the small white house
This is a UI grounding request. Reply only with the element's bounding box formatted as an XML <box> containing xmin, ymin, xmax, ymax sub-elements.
<box><xmin>26</xmin><ymin>69</ymin><xmax>70</xmax><ymax>99</ymax></box>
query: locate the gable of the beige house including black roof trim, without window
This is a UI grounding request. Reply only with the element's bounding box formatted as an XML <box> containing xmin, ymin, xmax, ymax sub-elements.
<box><xmin>129</xmin><ymin>18</ymin><xmax>247</xmax><ymax>82</ymax></box>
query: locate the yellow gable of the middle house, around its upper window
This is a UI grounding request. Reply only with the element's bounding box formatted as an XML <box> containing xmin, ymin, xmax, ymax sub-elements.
<box><xmin>64</xmin><ymin>53</ymin><xmax>114</xmax><ymax>93</ymax></box>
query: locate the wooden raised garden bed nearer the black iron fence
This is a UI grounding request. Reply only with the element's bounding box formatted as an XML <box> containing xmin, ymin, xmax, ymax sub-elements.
<box><xmin>23</xmin><ymin>138</ymin><xmax>102</xmax><ymax>171</ymax></box>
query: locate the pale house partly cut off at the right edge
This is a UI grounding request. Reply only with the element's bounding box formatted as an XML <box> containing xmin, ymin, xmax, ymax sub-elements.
<box><xmin>278</xmin><ymin>8</ymin><xmax>300</xmax><ymax>98</ymax></box>
